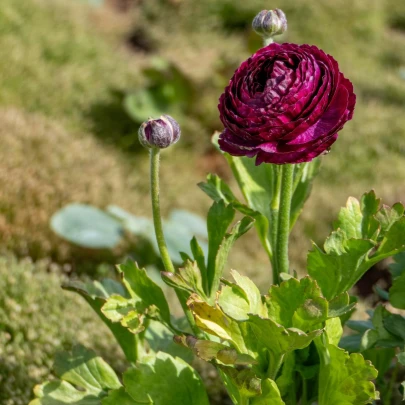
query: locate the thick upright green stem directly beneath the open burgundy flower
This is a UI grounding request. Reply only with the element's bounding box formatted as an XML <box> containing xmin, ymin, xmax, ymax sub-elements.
<box><xmin>273</xmin><ymin>164</ymin><xmax>294</xmax><ymax>284</ymax></box>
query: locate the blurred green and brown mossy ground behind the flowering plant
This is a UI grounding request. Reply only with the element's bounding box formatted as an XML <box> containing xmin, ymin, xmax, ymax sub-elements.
<box><xmin>0</xmin><ymin>0</ymin><xmax>405</xmax><ymax>405</ymax></box>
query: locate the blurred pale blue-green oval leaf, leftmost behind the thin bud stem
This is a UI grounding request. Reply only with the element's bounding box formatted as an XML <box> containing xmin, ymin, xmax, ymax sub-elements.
<box><xmin>51</xmin><ymin>204</ymin><xmax>124</xmax><ymax>249</ymax></box>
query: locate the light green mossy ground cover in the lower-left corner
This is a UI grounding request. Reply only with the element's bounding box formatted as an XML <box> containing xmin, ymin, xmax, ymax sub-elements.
<box><xmin>0</xmin><ymin>255</ymin><xmax>125</xmax><ymax>405</ymax></box>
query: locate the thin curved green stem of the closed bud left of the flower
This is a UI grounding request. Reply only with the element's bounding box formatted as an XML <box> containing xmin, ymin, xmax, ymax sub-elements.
<box><xmin>150</xmin><ymin>148</ymin><xmax>200</xmax><ymax>336</ymax></box>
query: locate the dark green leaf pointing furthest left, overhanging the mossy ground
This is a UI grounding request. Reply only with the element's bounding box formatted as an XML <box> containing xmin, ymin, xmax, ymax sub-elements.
<box><xmin>62</xmin><ymin>279</ymin><xmax>138</xmax><ymax>362</ymax></box>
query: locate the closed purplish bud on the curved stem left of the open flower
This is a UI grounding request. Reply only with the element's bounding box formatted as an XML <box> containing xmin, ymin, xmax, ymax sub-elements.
<box><xmin>138</xmin><ymin>115</ymin><xmax>180</xmax><ymax>149</ymax></box>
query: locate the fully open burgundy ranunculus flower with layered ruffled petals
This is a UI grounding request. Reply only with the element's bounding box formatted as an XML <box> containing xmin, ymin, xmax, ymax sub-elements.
<box><xmin>218</xmin><ymin>43</ymin><xmax>356</xmax><ymax>165</ymax></box>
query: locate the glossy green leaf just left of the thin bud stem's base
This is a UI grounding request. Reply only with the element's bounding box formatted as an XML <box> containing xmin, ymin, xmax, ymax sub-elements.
<box><xmin>117</xmin><ymin>260</ymin><xmax>171</xmax><ymax>325</ymax></box>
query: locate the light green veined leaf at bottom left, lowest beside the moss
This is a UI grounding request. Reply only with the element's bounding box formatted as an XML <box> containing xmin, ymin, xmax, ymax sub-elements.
<box><xmin>30</xmin><ymin>345</ymin><xmax>121</xmax><ymax>405</ymax></box>
